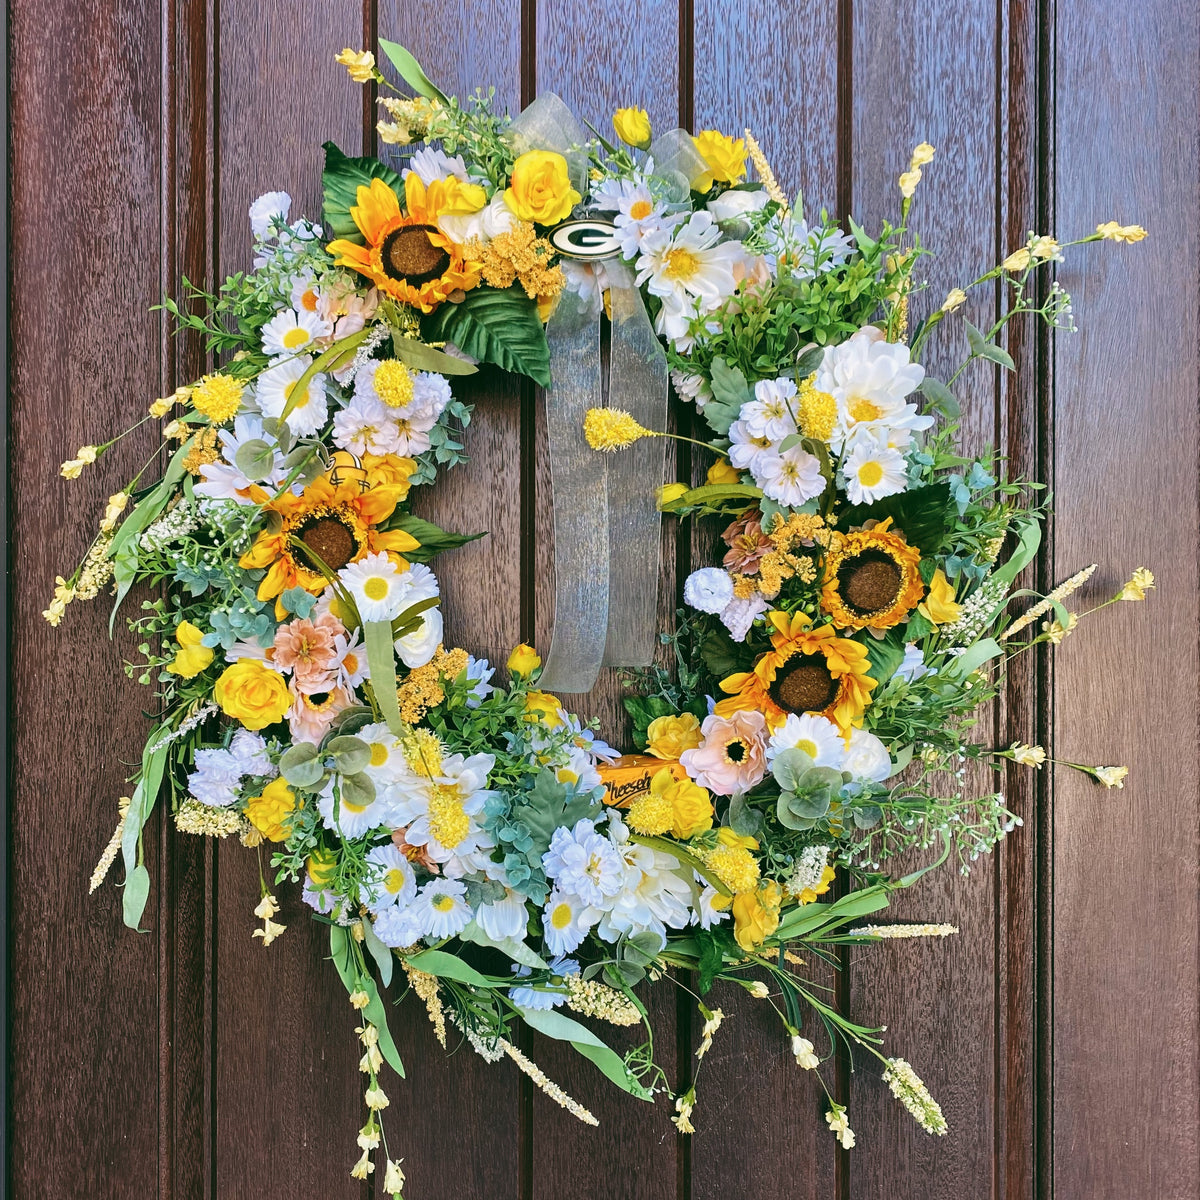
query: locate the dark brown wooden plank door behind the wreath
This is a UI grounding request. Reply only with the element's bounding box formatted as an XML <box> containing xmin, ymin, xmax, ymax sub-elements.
<box><xmin>6</xmin><ymin>0</ymin><xmax>1200</xmax><ymax>1200</ymax></box>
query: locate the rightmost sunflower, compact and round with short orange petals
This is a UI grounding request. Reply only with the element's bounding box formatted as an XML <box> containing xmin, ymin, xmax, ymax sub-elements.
<box><xmin>821</xmin><ymin>521</ymin><xmax>925</xmax><ymax>629</ymax></box>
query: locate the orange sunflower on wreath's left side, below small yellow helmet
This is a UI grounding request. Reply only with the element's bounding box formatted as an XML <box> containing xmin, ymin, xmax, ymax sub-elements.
<box><xmin>239</xmin><ymin>475</ymin><xmax>420</xmax><ymax>619</ymax></box>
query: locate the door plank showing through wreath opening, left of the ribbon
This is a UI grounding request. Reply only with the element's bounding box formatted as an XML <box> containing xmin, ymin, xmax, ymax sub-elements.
<box><xmin>360</xmin><ymin>7</ymin><xmax>523</xmax><ymax>1200</ymax></box>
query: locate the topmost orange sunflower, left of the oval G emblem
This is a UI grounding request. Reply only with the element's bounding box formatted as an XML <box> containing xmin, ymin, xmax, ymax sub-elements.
<box><xmin>329</xmin><ymin>172</ymin><xmax>487</xmax><ymax>312</ymax></box>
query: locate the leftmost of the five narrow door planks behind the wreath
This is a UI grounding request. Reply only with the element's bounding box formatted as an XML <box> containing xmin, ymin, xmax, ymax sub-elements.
<box><xmin>215</xmin><ymin>0</ymin><xmax>367</xmax><ymax>1200</ymax></box>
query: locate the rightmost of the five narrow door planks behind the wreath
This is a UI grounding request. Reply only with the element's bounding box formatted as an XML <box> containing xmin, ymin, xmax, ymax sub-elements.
<box><xmin>844</xmin><ymin>0</ymin><xmax>1003</xmax><ymax>1200</ymax></box>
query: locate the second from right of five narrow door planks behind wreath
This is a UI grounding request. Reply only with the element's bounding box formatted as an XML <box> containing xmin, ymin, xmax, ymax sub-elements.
<box><xmin>691</xmin><ymin>0</ymin><xmax>839</xmax><ymax>1200</ymax></box>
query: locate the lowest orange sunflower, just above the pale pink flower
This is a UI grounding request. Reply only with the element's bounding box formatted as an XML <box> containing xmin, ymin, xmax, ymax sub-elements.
<box><xmin>713</xmin><ymin>611</ymin><xmax>875</xmax><ymax>734</ymax></box>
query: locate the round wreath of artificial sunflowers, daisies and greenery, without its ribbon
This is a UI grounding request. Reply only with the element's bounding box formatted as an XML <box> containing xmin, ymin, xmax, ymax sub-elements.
<box><xmin>46</xmin><ymin>41</ymin><xmax>1153</xmax><ymax>1195</ymax></box>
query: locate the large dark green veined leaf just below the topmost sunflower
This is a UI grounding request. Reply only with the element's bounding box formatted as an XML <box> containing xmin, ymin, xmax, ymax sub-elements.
<box><xmin>421</xmin><ymin>287</ymin><xmax>551</xmax><ymax>388</ymax></box>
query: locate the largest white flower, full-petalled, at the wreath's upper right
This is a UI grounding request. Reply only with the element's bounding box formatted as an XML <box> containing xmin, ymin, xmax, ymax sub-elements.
<box><xmin>814</xmin><ymin>325</ymin><xmax>934</xmax><ymax>454</ymax></box>
